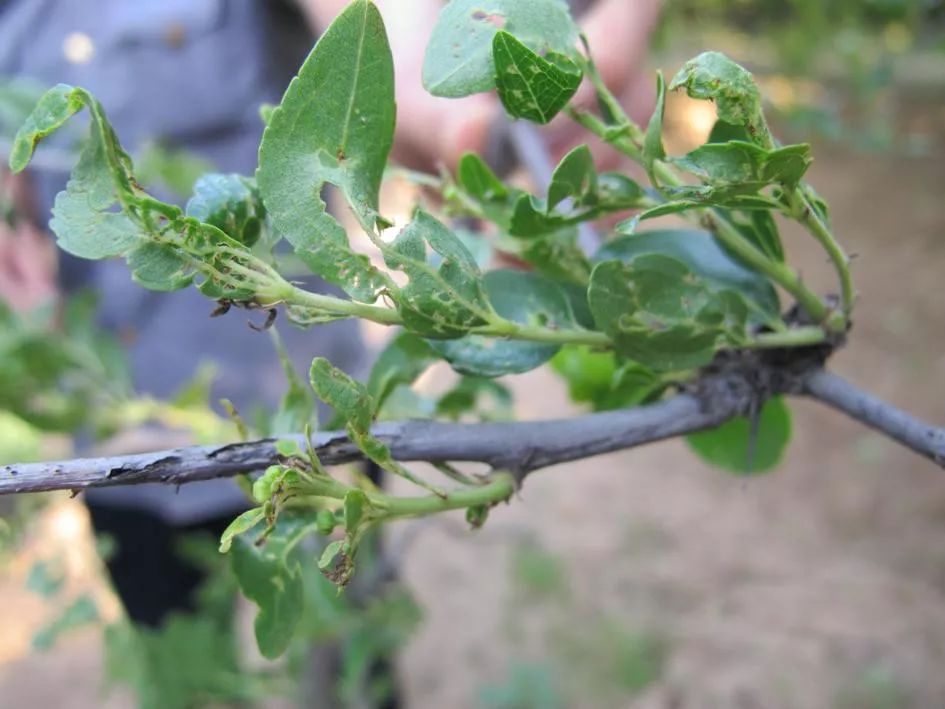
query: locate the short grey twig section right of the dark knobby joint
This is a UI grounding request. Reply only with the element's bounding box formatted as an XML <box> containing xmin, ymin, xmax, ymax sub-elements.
<box><xmin>804</xmin><ymin>369</ymin><xmax>945</xmax><ymax>468</ymax></box>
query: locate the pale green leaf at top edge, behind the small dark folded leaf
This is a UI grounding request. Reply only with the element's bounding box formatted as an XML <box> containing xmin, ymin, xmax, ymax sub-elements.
<box><xmin>423</xmin><ymin>0</ymin><xmax>578</xmax><ymax>98</ymax></box>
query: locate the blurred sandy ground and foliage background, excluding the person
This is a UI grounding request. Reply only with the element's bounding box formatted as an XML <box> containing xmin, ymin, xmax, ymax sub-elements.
<box><xmin>0</xmin><ymin>0</ymin><xmax>945</xmax><ymax>709</ymax></box>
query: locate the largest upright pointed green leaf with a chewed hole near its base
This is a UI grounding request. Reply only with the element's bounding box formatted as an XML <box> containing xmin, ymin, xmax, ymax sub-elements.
<box><xmin>257</xmin><ymin>0</ymin><xmax>395</xmax><ymax>302</ymax></box>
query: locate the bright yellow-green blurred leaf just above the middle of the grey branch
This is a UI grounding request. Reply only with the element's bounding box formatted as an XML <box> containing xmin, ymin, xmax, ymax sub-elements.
<box><xmin>551</xmin><ymin>345</ymin><xmax>666</xmax><ymax>411</ymax></box>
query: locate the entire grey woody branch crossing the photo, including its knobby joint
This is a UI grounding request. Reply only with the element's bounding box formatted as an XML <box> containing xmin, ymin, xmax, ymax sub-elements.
<box><xmin>0</xmin><ymin>362</ymin><xmax>945</xmax><ymax>495</ymax></box>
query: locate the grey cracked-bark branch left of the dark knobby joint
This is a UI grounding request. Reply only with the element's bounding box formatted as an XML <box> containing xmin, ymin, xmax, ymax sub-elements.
<box><xmin>0</xmin><ymin>378</ymin><xmax>745</xmax><ymax>495</ymax></box>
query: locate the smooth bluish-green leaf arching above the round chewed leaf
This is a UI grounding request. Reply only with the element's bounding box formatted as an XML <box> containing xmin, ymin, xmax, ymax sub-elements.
<box><xmin>594</xmin><ymin>229</ymin><xmax>781</xmax><ymax>318</ymax></box>
